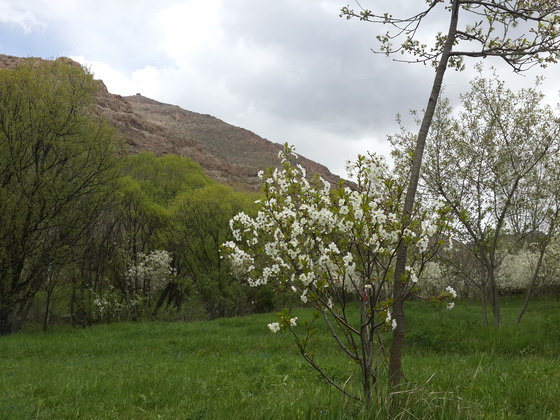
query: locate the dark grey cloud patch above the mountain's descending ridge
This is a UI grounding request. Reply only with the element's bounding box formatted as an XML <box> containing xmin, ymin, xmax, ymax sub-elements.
<box><xmin>210</xmin><ymin>2</ymin><xmax>438</xmax><ymax>142</ymax></box>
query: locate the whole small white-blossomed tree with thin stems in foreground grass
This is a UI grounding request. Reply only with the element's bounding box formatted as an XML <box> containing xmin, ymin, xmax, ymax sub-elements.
<box><xmin>224</xmin><ymin>145</ymin><xmax>455</xmax><ymax>403</ymax></box>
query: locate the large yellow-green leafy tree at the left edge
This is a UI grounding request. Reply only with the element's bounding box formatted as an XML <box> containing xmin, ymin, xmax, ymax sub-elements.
<box><xmin>0</xmin><ymin>60</ymin><xmax>117</xmax><ymax>334</ymax></box>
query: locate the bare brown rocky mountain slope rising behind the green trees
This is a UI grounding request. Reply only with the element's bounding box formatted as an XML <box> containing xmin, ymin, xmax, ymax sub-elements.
<box><xmin>0</xmin><ymin>55</ymin><xmax>340</xmax><ymax>190</ymax></box>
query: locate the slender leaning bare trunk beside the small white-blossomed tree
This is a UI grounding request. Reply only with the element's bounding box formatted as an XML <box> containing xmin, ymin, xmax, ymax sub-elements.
<box><xmin>389</xmin><ymin>0</ymin><xmax>459</xmax><ymax>387</ymax></box>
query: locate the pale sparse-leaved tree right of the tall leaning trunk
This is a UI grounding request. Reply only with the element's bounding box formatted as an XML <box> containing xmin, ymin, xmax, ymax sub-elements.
<box><xmin>423</xmin><ymin>73</ymin><xmax>560</xmax><ymax>325</ymax></box>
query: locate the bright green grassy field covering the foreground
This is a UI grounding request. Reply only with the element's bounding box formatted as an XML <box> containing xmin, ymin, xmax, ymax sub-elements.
<box><xmin>0</xmin><ymin>300</ymin><xmax>560</xmax><ymax>420</ymax></box>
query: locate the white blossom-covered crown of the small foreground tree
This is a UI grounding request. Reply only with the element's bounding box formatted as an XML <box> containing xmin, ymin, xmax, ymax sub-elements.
<box><xmin>223</xmin><ymin>146</ymin><xmax>452</xmax><ymax>322</ymax></box>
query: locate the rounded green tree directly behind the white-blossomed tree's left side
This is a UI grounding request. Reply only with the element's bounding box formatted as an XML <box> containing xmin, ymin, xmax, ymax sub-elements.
<box><xmin>168</xmin><ymin>184</ymin><xmax>271</xmax><ymax>318</ymax></box>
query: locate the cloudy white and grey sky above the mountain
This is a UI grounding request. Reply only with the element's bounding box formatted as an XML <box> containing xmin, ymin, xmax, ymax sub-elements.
<box><xmin>0</xmin><ymin>0</ymin><xmax>560</xmax><ymax>176</ymax></box>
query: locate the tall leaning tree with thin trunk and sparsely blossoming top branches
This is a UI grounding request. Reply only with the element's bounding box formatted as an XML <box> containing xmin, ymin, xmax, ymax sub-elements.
<box><xmin>341</xmin><ymin>0</ymin><xmax>560</xmax><ymax>386</ymax></box>
